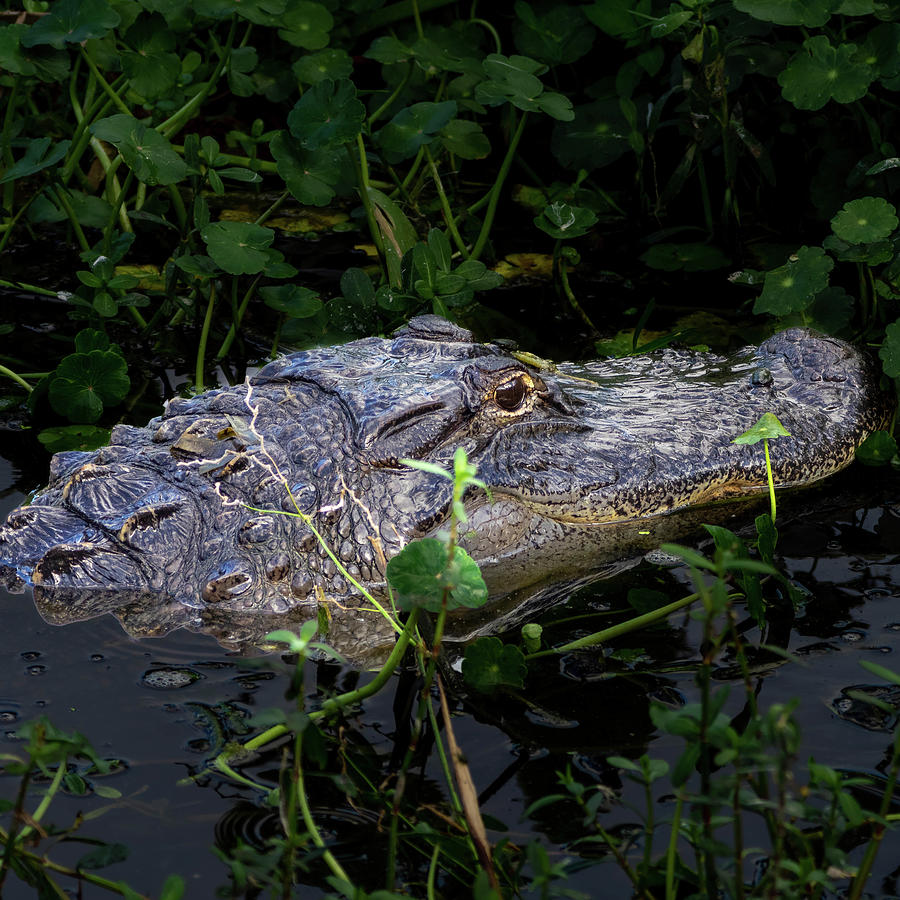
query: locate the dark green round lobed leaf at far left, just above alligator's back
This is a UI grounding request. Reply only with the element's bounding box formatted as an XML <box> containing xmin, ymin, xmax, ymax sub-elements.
<box><xmin>48</xmin><ymin>350</ymin><xmax>131</xmax><ymax>422</ymax></box>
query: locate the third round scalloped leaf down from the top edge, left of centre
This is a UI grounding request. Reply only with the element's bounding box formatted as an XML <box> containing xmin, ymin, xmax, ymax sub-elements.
<box><xmin>287</xmin><ymin>78</ymin><xmax>366</xmax><ymax>150</ymax></box>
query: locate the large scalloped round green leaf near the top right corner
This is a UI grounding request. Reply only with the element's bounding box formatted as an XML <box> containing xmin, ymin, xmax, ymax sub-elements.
<box><xmin>778</xmin><ymin>34</ymin><xmax>875</xmax><ymax>109</ymax></box>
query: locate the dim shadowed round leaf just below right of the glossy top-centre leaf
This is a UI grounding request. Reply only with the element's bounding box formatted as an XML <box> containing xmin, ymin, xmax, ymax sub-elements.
<box><xmin>550</xmin><ymin>97</ymin><xmax>631</xmax><ymax>172</ymax></box>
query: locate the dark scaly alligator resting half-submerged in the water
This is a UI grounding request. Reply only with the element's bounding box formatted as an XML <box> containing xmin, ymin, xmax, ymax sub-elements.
<box><xmin>0</xmin><ymin>316</ymin><xmax>892</xmax><ymax>659</ymax></box>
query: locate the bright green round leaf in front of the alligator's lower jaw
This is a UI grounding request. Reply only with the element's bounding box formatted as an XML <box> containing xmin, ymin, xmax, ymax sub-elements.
<box><xmin>387</xmin><ymin>538</ymin><xmax>487</xmax><ymax>612</ymax></box>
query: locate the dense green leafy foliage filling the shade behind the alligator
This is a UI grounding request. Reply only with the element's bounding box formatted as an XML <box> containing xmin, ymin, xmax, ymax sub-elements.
<box><xmin>0</xmin><ymin>0</ymin><xmax>900</xmax><ymax>447</ymax></box>
